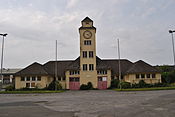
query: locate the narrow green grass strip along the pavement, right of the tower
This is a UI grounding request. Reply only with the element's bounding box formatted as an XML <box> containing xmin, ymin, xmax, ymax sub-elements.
<box><xmin>113</xmin><ymin>87</ymin><xmax>175</xmax><ymax>91</ymax></box>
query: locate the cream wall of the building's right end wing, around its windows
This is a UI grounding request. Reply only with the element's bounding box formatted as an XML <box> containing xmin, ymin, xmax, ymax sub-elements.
<box><xmin>124</xmin><ymin>73</ymin><xmax>162</xmax><ymax>84</ymax></box>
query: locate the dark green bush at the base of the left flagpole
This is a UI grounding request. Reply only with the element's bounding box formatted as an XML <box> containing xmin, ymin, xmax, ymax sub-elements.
<box><xmin>47</xmin><ymin>80</ymin><xmax>62</xmax><ymax>90</ymax></box>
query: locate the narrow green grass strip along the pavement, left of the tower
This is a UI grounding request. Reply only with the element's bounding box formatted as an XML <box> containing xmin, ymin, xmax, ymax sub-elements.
<box><xmin>0</xmin><ymin>90</ymin><xmax>64</xmax><ymax>94</ymax></box>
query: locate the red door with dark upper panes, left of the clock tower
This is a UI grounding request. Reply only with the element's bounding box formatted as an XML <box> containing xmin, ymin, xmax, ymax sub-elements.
<box><xmin>69</xmin><ymin>77</ymin><xmax>80</xmax><ymax>90</ymax></box>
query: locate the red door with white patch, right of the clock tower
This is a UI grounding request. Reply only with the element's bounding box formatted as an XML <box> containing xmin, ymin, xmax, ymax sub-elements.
<box><xmin>98</xmin><ymin>77</ymin><xmax>107</xmax><ymax>90</ymax></box>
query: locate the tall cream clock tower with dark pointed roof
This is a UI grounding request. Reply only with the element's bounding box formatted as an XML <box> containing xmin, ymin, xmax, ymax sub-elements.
<box><xmin>79</xmin><ymin>17</ymin><xmax>97</xmax><ymax>88</ymax></box>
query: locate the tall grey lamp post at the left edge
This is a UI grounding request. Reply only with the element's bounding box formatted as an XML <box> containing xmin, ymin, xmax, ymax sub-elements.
<box><xmin>0</xmin><ymin>33</ymin><xmax>7</xmax><ymax>90</ymax></box>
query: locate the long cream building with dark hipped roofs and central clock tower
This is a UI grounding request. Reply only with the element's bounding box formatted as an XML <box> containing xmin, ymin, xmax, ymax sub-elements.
<box><xmin>15</xmin><ymin>17</ymin><xmax>161</xmax><ymax>90</ymax></box>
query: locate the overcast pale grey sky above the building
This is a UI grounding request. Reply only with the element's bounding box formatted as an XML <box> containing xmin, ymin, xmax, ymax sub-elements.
<box><xmin>0</xmin><ymin>0</ymin><xmax>175</xmax><ymax>68</ymax></box>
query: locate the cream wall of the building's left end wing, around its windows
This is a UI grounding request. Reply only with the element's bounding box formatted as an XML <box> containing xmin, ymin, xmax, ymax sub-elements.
<box><xmin>15</xmin><ymin>76</ymin><xmax>53</xmax><ymax>89</ymax></box>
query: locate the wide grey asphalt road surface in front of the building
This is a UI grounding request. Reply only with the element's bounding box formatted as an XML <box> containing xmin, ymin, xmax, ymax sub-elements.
<box><xmin>0</xmin><ymin>90</ymin><xmax>175</xmax><ymax>117</ymax></box>
